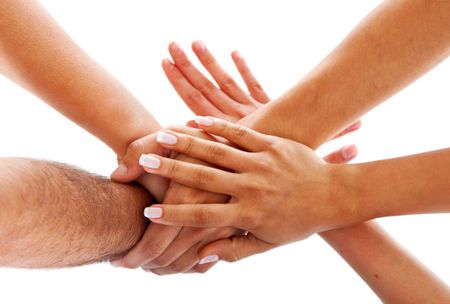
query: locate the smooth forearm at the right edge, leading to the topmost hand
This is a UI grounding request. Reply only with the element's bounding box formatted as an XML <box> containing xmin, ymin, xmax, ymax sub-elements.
<box><xmin>340</xmin><ymin>149</ymin><xmax>450</xmax><ymax>222</ymax></box>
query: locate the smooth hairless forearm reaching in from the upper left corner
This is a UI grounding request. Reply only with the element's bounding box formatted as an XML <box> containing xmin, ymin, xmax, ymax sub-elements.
<box><xmin>0</xmin><ymin>0</ymin><xmax>159</xmax><ymax>156</ymax></box>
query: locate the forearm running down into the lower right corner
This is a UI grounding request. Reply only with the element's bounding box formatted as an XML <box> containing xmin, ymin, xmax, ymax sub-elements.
<box><xmin>320</xmin><ymin>222</ymin><xmax>450</xmax><ymax>303</ymax></box>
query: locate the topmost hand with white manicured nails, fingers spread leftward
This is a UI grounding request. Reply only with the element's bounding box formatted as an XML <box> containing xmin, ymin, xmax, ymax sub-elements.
<box><xmin>143</xmin><ymin>117</ymin><xmax>357</xmax><ymax>264</ymax></box>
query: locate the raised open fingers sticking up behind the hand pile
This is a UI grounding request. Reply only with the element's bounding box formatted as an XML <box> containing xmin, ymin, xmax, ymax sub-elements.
<box><xmin>162</xmin><ymin>41</ymin><xmax>270</xmax><ymax>122</ymax></box>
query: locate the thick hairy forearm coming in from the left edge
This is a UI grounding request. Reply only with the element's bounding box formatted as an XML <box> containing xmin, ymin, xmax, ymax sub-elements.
<box><xmin>0</xmin><ymin>158</ymin><xmax>150</xmax><ymax>268</ymax></box>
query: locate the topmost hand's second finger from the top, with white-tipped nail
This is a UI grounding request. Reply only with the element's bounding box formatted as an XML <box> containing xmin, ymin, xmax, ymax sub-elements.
<box><xmin>156</xmin><ymin>131</ymin><xmax>254</xmax><ymax>171</ymax></box>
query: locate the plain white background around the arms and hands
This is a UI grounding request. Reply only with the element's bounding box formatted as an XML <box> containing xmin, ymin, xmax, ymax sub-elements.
<box><xmin>0</xmin><ymin>0</ymin><xmax>450</xmax><ymax>303</ymax></box>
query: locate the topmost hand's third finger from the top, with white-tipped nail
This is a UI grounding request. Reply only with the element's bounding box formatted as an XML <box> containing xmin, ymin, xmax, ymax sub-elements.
<box><xmin>139</xmin><ymin>154</ymin><xmax>239</xmax><ymax>196</ymax></box>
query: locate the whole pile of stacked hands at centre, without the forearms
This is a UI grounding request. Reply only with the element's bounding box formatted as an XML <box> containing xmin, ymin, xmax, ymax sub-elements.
<box><xmin>113</xmin><ymin>42</ymin><xmax>360</xmax><ymax>274</ymax></box>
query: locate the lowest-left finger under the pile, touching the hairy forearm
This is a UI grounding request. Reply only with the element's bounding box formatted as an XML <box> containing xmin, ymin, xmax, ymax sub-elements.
<box><xmin>114</xmin><ymin>223</ymin><xmax>181</xmax><ymax>268</ymax></box>
